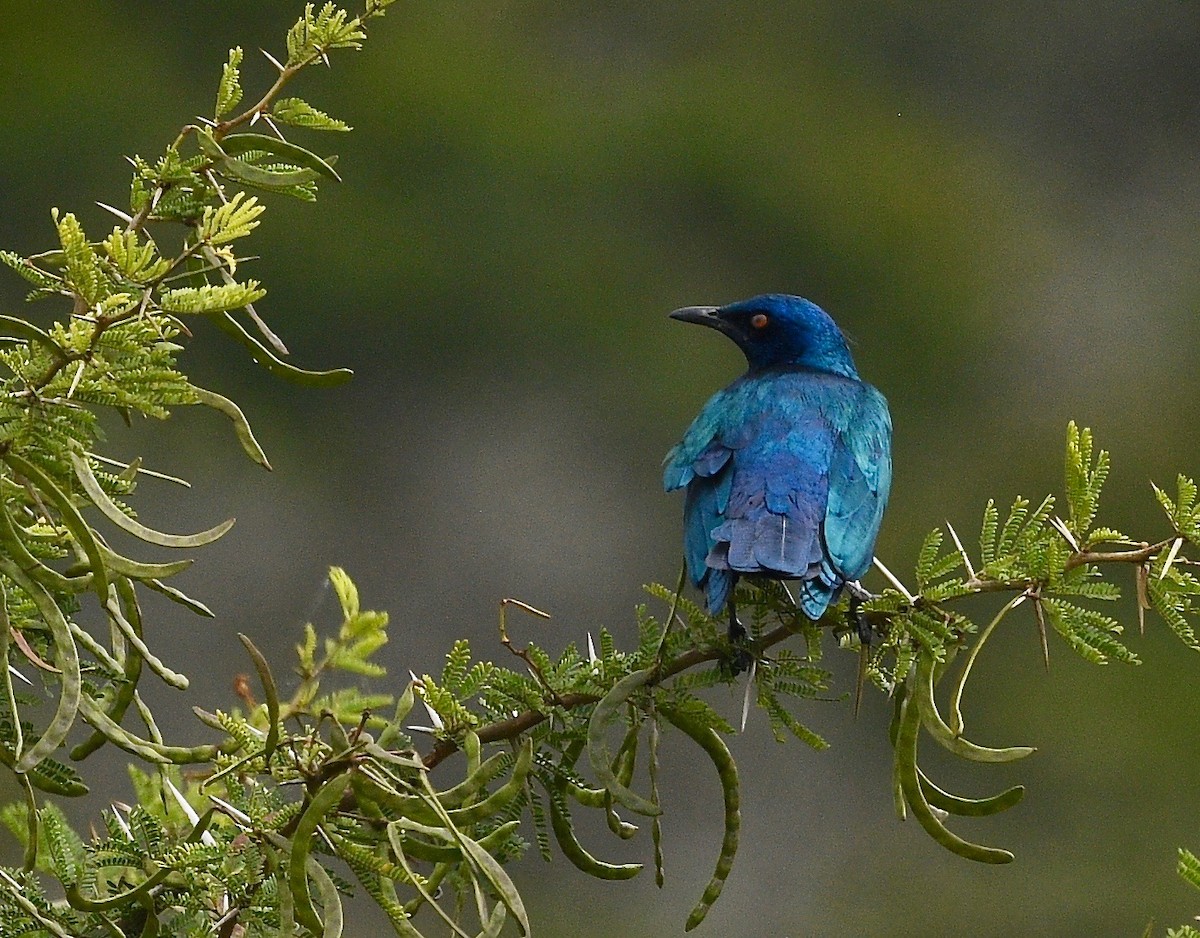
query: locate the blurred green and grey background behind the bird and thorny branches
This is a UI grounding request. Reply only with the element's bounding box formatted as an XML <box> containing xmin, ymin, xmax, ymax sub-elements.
<box><xmin>0</xmin><ymin>0</ymin><xmax>1200</xmax><ymax>938</ymax></box>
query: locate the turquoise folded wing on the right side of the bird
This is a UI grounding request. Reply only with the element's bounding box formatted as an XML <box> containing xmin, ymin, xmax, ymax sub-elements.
<box><xmin>823</xmin><ymin>384</ymin><xmax>892</xmax><ymax>579</ymax></box>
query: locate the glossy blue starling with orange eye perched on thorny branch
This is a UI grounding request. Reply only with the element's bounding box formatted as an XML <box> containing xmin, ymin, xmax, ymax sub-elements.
<box><xmin>662</xmin><ymin>294</ymin><xmax>892</xmax><ymax>642</ymax></box>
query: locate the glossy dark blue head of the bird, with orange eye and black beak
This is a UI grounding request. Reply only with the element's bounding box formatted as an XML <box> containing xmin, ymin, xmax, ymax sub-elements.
<box><xmin>671</xmin><ymin>293</ymin><xmax>858</xmax><ymax>378</ymax></box>
